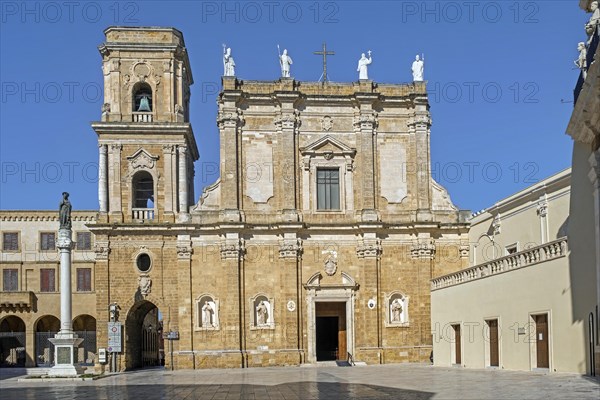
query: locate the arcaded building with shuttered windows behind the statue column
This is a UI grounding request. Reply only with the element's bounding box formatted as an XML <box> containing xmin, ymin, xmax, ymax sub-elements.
<box><xmin>0</xmin><ymin>211</ymin><xmax>97</xmax><ymax>367</ymax></box>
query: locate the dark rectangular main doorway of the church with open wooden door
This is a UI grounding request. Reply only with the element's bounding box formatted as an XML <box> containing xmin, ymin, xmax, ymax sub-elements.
<box><xmin>315</xmin><ymin>302</ymin><xmax>347</xmax><ymax>361</ymax></box>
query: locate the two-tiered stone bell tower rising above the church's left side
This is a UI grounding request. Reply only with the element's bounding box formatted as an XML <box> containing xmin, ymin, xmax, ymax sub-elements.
<box><xmin>92</xmin><ymin>26</ymin><xmax>198</xmax><ymax>223</ymax></box>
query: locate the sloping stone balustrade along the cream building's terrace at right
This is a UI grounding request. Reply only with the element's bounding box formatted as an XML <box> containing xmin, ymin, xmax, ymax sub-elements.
<box><xmin>431</xmin><ymin>237</ymin><xmax>567</xmax><ymax>290</ymax></box>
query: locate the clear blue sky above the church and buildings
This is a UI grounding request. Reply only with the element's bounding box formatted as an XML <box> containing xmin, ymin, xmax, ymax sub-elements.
<box><xmin>0</xmin><ymin>0</ymin><xmax>589</xmax><ymax>211</ymax></box>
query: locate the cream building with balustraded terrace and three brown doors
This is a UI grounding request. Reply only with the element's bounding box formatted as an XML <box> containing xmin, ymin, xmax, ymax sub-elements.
<box><xmin>431</xmin><ymin>169</ymin><xmax>587</xmax><ymax>372</ymax></box>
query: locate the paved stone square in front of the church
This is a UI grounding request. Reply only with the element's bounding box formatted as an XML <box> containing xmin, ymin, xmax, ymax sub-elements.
<box><xmin>0</xmin><ymin>364</ymin><xmax>600</xmax><ymax>400</ymax></box>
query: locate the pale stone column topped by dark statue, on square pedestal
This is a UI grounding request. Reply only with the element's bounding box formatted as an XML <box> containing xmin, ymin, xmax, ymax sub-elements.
<box><xmin>48</xmin><ymin>192</ymin><xmax>83</xmax><ymax>376</ymax></box>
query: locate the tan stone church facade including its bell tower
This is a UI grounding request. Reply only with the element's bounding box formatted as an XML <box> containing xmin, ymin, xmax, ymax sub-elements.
<box><xmin>0</xmin><ymin>27</ymin><xmax>469</xmax><ymax>369</ymax></box>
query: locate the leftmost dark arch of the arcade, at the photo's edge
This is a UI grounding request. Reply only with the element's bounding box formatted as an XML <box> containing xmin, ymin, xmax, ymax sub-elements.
<box><xmin>0</xmin><ymin>315</ymin><xmax>27</xmax><ymax>367</ymax></box>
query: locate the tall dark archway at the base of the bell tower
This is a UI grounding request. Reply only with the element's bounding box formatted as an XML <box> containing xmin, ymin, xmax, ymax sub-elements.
<box><xmin>125</xmin><ymin>300</ymin><xmax>164</xmax><ymax>369</ymax></box>
